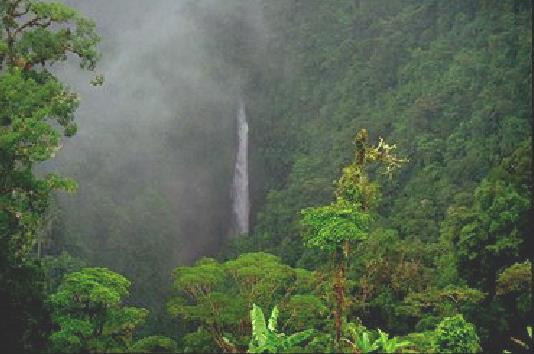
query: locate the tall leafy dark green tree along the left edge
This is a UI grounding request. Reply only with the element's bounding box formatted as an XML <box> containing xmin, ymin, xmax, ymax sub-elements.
<box><xmin>0</xmin><ymin>0</ymin><xmax>99</xmax><ymax>351</ymax></box>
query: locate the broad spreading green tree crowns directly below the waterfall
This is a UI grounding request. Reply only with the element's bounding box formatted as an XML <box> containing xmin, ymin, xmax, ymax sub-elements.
<box><xmin>168</xmin><ymin>253</ymin><xmax>326</xmax><ymax>351</ymax></box>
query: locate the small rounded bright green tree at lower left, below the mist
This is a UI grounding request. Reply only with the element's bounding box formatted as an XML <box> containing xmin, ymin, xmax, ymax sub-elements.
<box><xmin>50</xmin><ymin>268</ymin><xmax>148</xmax><ymax>352</ymax></box>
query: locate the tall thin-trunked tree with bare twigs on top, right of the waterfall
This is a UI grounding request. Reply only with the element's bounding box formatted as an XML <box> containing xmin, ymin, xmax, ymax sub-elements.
<box><xmin>302</xmin><ymin>129</ymin><xmax>406</xmax><ymax>344</ymax></box>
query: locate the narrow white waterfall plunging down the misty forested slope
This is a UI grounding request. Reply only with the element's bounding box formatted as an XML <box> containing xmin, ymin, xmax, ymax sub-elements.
<box><xmin>232</xmin><ymin>99</ymin><xmax>250</xmax><ymax>234</ymax></box>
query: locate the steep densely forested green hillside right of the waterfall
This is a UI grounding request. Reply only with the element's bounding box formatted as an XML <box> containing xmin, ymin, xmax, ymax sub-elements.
<box><xmin>220</xmin><ymin>1</ymin><xmax>532</xmax><ymax>351</ymax></box>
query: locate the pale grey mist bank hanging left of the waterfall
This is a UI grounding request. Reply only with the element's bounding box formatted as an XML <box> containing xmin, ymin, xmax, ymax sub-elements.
<box><xmin>45</xmin><ymin>0</ymin><xmax>270</xmax><ymax>316</ymax></box>
